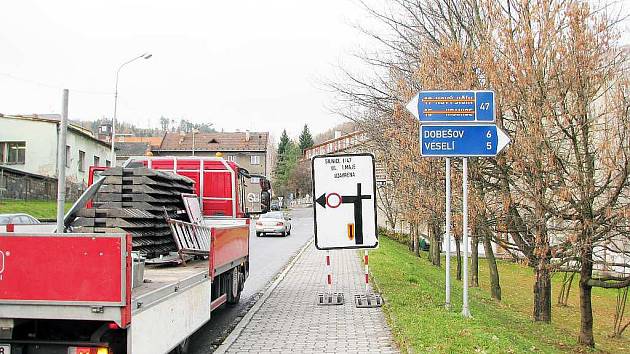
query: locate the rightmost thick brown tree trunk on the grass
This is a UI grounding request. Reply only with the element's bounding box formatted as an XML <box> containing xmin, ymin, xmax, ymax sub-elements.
<box><xmin>578</xmin><ymin>246</ymin><xmax>595</xmax><ymax>347</ymax></box>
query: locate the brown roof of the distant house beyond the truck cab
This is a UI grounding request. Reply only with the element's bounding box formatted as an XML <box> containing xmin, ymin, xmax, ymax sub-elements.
<box><xmin>159</xmin><ymin>132</ymin><xmax>269</xmax><ymax>151</ymax></box>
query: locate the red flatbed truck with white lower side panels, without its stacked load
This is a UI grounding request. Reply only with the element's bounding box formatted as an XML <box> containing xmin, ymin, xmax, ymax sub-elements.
<box><xmin>0</xmin><ymin>157</ymin><xmax>269</xmax><ymax>354</ymax></box>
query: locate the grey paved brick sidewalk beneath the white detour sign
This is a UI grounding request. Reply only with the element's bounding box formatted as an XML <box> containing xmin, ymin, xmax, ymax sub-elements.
<box><xmin>220</xmin><ymin>243</ymin><xmax>398</xmax><ymax>353</ymax></box>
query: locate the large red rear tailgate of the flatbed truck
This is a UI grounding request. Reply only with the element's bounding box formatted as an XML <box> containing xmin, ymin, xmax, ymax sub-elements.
<box><xmin>0</xmin><ymin>234</ymin><xmax>126</xmax><ymax>304</ymax></box>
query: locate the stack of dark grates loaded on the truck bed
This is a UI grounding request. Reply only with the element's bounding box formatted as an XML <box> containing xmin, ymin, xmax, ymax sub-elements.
<box><xmin>72</xmin><ymin>167</ymin><xmax>194</xmax><ymax>258</ymax></box>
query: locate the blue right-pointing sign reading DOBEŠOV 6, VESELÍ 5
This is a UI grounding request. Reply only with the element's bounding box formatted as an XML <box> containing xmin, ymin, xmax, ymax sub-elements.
<box><xmin>420</xmin><ymin>124</ymin><xmax>510</xmax><ymax>157</ymax></box>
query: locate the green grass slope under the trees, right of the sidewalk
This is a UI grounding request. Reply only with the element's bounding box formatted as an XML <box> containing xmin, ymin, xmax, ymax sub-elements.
<box><xmin>370</xmin><ymin>237</ymin><xmax>630</xmax><ymax>353</ymax></box>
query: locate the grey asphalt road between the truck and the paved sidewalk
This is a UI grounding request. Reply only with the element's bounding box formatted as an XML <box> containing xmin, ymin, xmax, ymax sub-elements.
<box><xmin>189</xmin><ymin>208</ymin><xmax>313</xmax><ymax>354</ymax></box>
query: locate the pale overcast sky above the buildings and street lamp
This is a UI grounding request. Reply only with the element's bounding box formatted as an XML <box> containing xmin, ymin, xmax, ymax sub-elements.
<box><xmin>0</xmin><ymin>0</ymin><xmax>376</xmax><ymax>141</ymax></box>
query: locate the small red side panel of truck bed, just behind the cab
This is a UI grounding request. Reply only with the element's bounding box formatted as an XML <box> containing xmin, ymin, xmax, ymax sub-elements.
<box><xmin>212</xmin><ymin>225</ymin><xmax>249</xmax><ymax>276</ymax></box>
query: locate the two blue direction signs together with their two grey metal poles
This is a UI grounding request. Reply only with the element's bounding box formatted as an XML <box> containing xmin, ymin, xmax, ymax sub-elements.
<box><xmin>407</xmin><ymin>91</ymin><xmax>510</xmax><ymax>317</ymax></box>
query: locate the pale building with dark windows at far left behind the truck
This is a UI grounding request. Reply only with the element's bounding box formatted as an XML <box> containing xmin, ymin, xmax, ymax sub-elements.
<box><xmin>0</xmin><ymin>114</ymin><xmax>111</xmax><ymax>185</ymax></box>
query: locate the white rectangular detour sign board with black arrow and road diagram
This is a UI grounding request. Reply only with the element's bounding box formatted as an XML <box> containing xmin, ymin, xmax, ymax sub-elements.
<box><xmin>312</xmin><ymin>154</ymin><xmax>378</xmax><ymax>250</ymax></box>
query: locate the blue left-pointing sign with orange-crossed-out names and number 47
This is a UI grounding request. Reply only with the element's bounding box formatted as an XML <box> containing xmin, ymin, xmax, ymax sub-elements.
<box><xmin>407</xmin><ymin>91</ymin><xmax>495</xmax><ymax>124</ymax></box>
